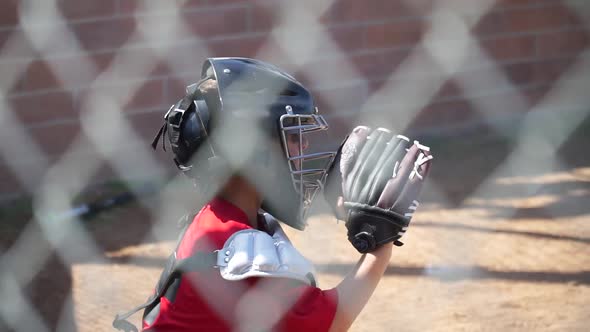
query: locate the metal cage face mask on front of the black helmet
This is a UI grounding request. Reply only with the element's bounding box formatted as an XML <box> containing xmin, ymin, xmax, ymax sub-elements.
<box><xmin>280</xmin><ymin>110</ymin><xmax>336</xmax><ymax>220</ymax></box>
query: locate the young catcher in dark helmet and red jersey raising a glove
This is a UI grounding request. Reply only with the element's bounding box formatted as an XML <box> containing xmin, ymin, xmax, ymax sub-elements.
<box><xmin>114</xmin><ymin>58</ymin><xmax>431</xmax><ymax>331</ymax></box>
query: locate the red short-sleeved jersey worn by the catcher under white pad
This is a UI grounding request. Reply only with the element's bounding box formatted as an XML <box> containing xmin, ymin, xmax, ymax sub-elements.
<box><xmin>143</xmin><ymin>198</ymin><xmax>337</xmax><ymax>331</ymax></box>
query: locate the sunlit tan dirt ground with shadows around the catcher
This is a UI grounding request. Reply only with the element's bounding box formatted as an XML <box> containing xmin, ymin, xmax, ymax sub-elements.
<box><xmin>0</xmin><ymin>124</ymin><xmax>590</xmax><ymax>332</ymax></box>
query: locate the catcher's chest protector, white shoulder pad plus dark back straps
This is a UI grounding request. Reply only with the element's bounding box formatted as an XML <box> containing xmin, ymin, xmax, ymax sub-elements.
<box><xmin>113</xmin><ymin>213</ymin><xmax>316</xmax><ymax>331</ymax></box>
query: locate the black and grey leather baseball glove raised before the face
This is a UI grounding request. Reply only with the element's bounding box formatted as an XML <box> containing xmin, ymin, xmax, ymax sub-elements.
<box><xmin>324</xmin><ymin>126</ymin><xmax>433</xmax><ymax>253</ymax></box>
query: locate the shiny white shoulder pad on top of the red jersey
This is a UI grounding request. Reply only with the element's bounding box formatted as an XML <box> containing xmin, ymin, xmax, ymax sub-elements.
<box><xmin>217</xmin><ymin>216</ymin><xmax>316</xmax><ymax>286</ymax></box>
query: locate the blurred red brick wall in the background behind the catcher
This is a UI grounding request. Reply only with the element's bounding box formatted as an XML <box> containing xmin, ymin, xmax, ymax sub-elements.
<box><xmin>0</xmin><ymin>0</ymin><xmax>590</xmax><ymax>200</ymax></box>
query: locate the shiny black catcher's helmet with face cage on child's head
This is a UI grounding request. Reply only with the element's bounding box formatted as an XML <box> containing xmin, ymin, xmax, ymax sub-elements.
<box><xmin>152</xmin><ymin>58</ymin><xmax>335</xmax><ymax>229</ymax></box>
